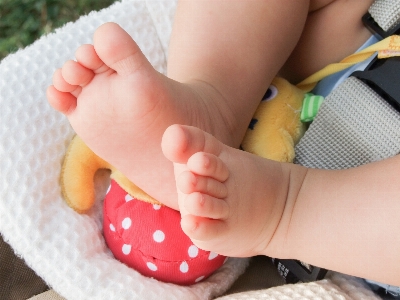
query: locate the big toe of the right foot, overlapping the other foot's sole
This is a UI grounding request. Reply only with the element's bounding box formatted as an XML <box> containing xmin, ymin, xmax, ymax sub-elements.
<box><xmin>161</xmin><ymin>125</ymin><xmax>223</xmax><ymax>164</ymax></box>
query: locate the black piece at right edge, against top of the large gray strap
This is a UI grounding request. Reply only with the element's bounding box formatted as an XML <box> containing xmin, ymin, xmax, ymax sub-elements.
<box><xmin>351</xmin><ymin>57</ymin><xmax>400</xmax><ymax>112</ymax></box>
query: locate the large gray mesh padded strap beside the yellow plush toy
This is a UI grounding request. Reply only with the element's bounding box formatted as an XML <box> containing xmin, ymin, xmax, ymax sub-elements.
<box><xmin>295</xmin><ymin>76</ymin><xmax>400</xmax><ymax>169</ymax></box>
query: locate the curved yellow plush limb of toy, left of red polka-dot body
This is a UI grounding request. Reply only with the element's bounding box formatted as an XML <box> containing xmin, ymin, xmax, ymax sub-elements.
<box><xmin>61</xmin><ymin>136</ymin><xmax>161</xmax><ymax>213</ymax></box>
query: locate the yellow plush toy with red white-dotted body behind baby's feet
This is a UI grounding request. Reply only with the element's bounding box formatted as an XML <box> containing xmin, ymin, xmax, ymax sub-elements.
<box><xmin>61</xmin><ymin>78</ymin><xmax>305</xmax><ymax>285</ymax></box>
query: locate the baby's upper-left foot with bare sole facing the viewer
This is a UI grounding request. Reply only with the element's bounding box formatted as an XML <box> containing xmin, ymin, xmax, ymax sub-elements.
<box><xmin>47</xmin><ymin>23</ymin><xmax>240</xmax><ymax>209</ymax></box>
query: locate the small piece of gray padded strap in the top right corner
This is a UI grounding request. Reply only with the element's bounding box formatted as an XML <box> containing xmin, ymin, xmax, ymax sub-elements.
<box><xmin>368</xmin><ymin>0</ymin><xmax>400</xmax><ymax>31</ymax></box>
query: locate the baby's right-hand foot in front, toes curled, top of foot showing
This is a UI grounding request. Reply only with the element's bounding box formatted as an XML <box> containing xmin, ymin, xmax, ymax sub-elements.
<box><xmin>162</xmin><ymin>125</ymin><xmax>291</xmax><ymax>257</ymax></box>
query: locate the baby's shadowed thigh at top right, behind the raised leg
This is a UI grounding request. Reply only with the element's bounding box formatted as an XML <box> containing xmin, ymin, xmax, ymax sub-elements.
<box><xmin>280</xmin><ymin>0</ymin><xmax>374</xmax><ymax>83</ymax></box>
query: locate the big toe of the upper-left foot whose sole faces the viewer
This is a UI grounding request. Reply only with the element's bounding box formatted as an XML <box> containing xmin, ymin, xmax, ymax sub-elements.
<box><xmin>93</xmin><ymin>23</ymin><xmax>151</xmax><ymax>75</ymax></box>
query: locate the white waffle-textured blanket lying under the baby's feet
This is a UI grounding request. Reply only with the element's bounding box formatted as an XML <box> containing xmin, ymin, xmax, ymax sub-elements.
<box><xmin>0</xmin><ymin>0</ymin><xmax>382</xmax><ymax>300</ymax></box>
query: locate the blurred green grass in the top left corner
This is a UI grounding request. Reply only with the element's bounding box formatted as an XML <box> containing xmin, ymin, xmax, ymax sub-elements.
<box><xmin>0</xmin><ymin>0</ymin><xmax>116</xmax><ymax>60</ymax></box>
